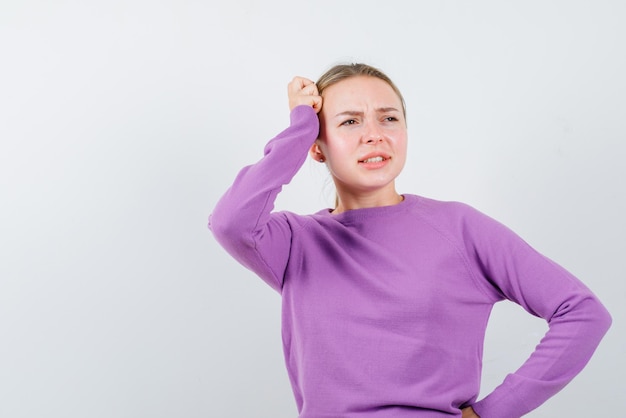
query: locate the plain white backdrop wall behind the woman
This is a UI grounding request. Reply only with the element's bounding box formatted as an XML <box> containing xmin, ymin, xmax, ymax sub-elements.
<box><xmin>0</xmin><ymin>0</ymin><xmax>626</xmax><ymax>418</ymax></box>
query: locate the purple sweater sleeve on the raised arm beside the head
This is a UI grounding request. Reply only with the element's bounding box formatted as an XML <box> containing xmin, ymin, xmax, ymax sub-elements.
<box><xmin>209</xmin><ymin>106</ymin><xmax>319</xmax><ymax>291</ymax></box>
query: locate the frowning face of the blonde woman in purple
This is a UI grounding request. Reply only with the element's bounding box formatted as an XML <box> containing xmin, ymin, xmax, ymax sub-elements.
<box><xmin>311</xmin><ymin>76</ymin><xmax>407</xmax><ymax>199</ymax></box>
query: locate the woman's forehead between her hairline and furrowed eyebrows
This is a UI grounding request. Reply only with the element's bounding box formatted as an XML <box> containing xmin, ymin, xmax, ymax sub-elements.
<box><xmin>322</xmin><ymin>76</ymin><xmax>402</xmax><ymax>111</ymax></box>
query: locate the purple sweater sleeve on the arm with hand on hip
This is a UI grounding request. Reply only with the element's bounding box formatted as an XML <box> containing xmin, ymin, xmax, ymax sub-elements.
<box><xmin>465</xmin><ymin>207</ymin><xmax>611</xmax><ymax>418</ymax></box>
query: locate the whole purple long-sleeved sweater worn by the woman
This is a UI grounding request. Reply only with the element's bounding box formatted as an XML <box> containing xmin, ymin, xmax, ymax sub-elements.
<box><xmin>209</xmin><ymin>106</ymin><xmax>611</xmax><ymax>418</ymax></box>
